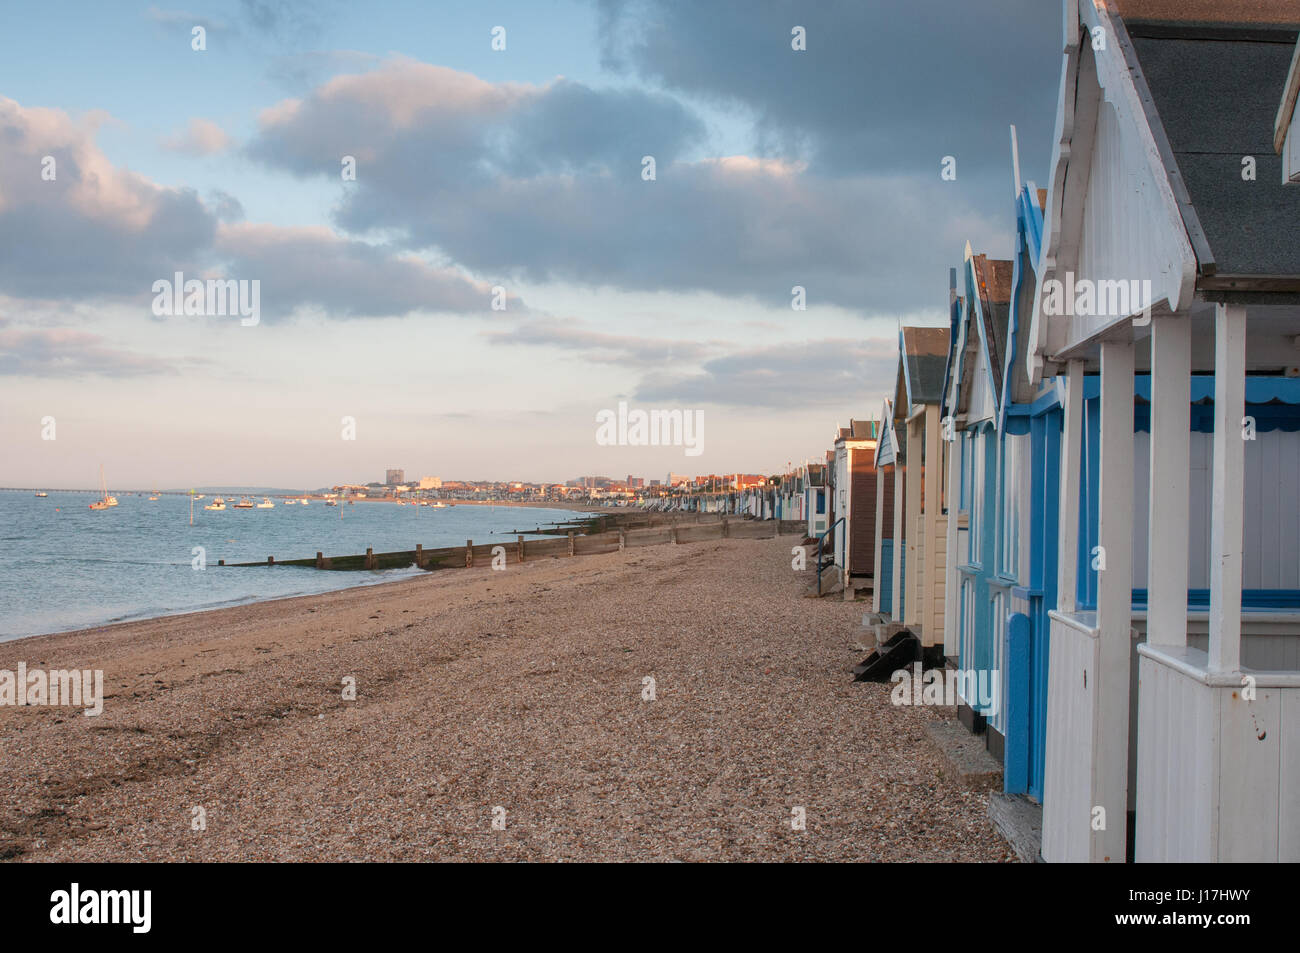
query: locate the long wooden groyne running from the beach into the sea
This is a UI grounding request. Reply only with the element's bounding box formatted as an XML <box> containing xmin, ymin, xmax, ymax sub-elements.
<box><xmin>217</xmin><ymin>512</ymin><xmax>806</xmax><ymax>572</ymax></box>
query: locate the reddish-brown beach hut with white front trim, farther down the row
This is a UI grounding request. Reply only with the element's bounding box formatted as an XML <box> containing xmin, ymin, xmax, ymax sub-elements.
<box><xmin>835</xmin><ymin>420</ymin><xmax>878</xmax><ymax>590</ymax></box>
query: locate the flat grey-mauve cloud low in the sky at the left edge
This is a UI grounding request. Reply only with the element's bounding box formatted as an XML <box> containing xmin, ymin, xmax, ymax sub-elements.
<box><xmin>0</xmin><ymin>321</ymin><xmax>202</xmax><ymax>378</ymax></box>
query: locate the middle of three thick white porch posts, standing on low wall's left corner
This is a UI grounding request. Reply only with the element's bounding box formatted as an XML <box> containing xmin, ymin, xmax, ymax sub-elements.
<box><xmin>1147</xmin><ymin>315</ymin><xmax>1192</xmax><ymax>646</ymax></box>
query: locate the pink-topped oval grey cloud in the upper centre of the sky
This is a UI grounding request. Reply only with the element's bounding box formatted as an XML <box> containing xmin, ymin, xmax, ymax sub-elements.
<box><xmin>248</xmin><ymin>57</ymin><xmax>703</xmax><ymax>184</ymax></box>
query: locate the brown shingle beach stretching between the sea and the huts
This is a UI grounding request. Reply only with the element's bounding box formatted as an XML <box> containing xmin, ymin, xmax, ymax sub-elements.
<box><xmin>0</xmin><ymin>537</ymin><xmax>1014</xmax><ymax>861</ymax></box>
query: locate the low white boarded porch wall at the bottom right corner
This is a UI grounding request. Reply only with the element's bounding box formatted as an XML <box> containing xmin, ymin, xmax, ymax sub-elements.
<box><xmin>1136</xmin><ymin>645</ymin><xmax>1300</xmax><ymax>863</ymax></box>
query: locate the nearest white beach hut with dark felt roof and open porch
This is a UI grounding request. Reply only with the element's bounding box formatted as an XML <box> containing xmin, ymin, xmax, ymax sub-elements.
<box><xmin>1024</xmin><ymin>0</ymin><xmax>1300</xmax><ymax>862</ymax></box>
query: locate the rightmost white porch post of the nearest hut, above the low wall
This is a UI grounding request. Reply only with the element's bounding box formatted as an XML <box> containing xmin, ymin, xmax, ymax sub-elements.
<box><xmin>1209</xmin><ymin>304</ymin><xmax>1245</xmax><ymax>672</ymax></box>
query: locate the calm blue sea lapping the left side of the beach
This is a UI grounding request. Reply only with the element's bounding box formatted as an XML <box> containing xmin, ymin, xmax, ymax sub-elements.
<box><xmin>0</xmin><ymin>490</ymin><xmax>595</xmax><ymax>641</ymax></box>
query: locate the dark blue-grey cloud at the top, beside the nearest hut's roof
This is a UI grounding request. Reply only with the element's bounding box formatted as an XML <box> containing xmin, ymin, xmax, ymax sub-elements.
<box><xmin>598</xmin><ymin>0</ymin><xmax>1061</xmax><ymax>182</ymax></box>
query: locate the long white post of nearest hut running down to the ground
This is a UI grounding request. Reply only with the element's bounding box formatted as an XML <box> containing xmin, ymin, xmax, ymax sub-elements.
<box><xmin>1092</xmin><ymin>341</ymin><xmax>1134</xmax><ymax>863</ymax></box>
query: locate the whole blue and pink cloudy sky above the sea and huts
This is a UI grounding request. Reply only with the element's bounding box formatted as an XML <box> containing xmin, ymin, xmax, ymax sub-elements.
<box><xmin>0</xmin><ymin>0</ymin><xmax>1061</xmax><ymax>488</ymax></box>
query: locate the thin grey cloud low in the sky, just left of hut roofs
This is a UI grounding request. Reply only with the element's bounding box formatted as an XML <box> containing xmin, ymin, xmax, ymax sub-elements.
<box><xmin>636</xmin><ymin>338</ymin><xmax>898</xmax><ymax>410</ymax></box>
